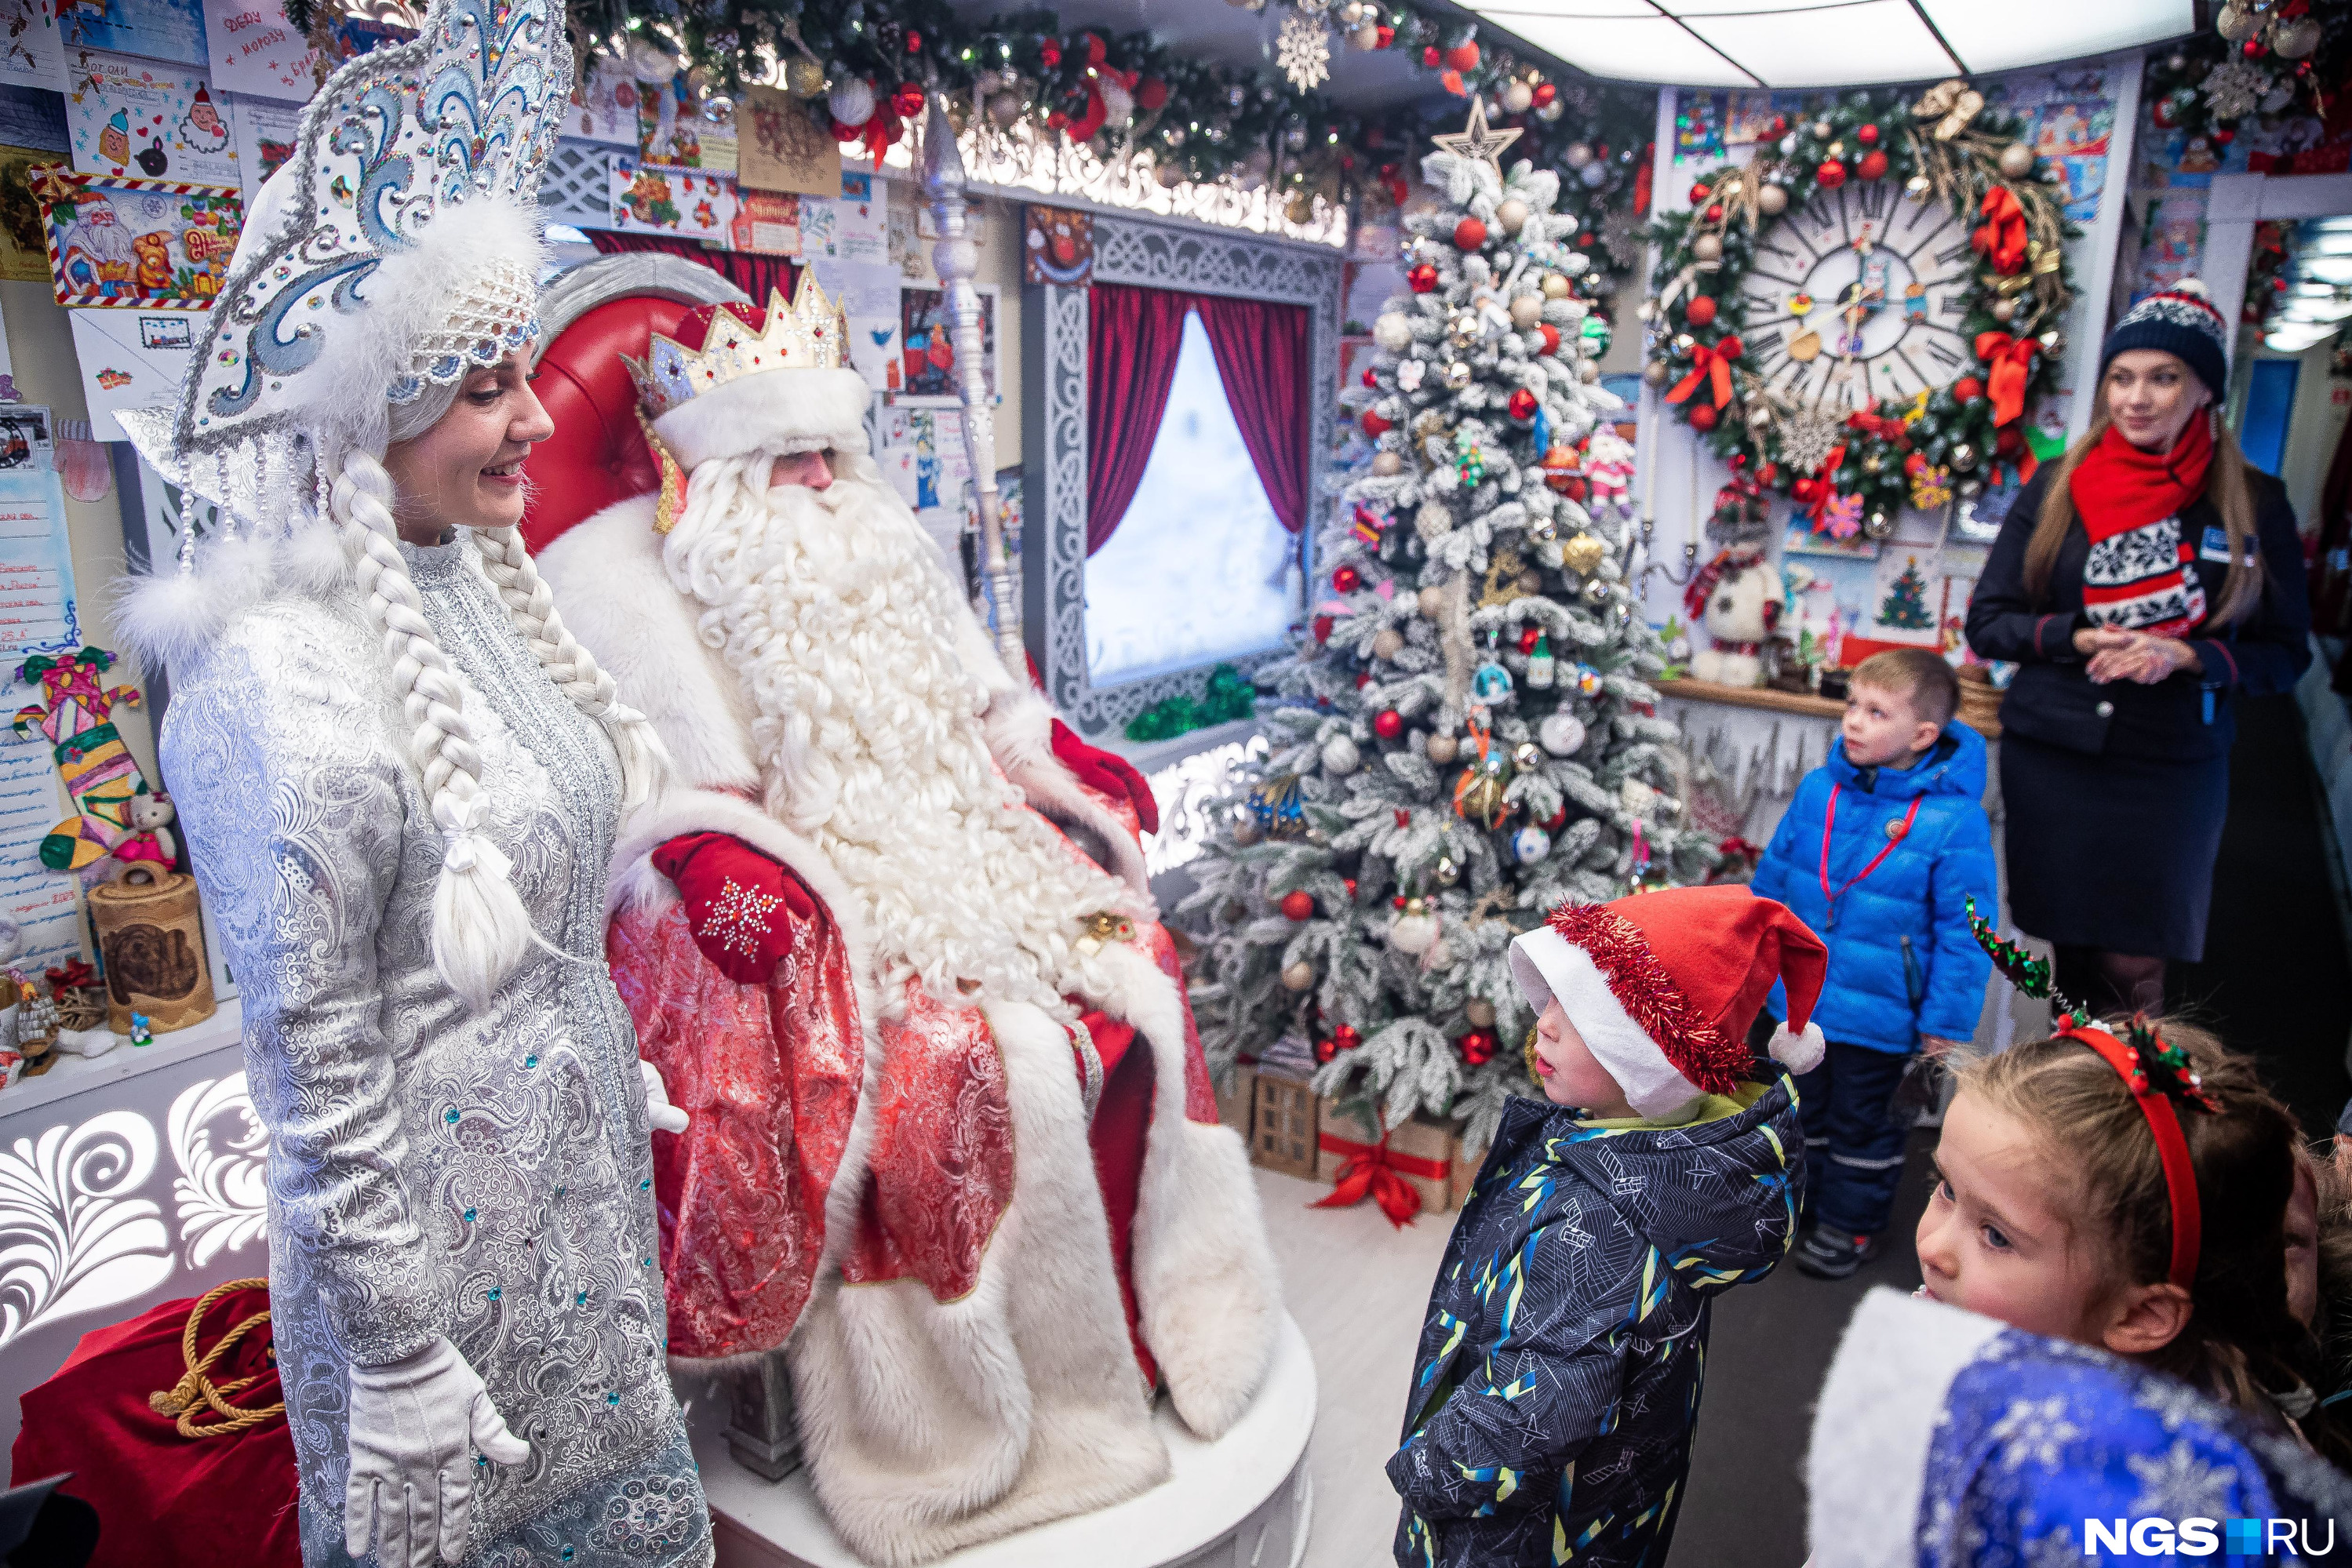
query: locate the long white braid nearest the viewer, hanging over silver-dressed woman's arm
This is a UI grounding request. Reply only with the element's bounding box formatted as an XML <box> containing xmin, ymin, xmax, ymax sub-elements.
<box><xmin>332</xmin><ymin>449</ymin><xmax>532</xmax><ymax>1011</ymax></box>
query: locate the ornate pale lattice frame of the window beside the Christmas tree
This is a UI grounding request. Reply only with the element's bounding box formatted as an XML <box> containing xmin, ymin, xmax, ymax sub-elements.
<box><xmin>1021</xmin><ymin>212</ymin><xmax>1343</xmax><ymax>736</ymax></box>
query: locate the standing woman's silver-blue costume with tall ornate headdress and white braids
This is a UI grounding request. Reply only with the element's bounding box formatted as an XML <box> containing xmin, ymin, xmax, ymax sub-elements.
<box><xmin>125</xmin><ymin>0</ymin><xmax>710</xmax><ymax>1568</ymax></box>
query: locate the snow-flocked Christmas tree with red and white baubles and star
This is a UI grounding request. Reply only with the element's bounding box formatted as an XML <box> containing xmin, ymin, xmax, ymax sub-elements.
<box><xmin>1178</xmin><ymin>108</ymin><xmax>1715</xmax><ymax>1148</ymax></box>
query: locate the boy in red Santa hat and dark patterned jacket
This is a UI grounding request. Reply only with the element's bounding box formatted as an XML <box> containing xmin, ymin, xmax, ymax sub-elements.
<box><xmin>1388</xmin><ymin>886</ymin><xmax>1827</xmax><ymax>1568</ymax></box>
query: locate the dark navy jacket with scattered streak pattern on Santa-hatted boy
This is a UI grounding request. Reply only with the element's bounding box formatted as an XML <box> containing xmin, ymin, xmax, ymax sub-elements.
<box><xmin>1388</xmin><ymin>1075</ymin><xmax>1804</xmax><ymax>1568</ymax></box>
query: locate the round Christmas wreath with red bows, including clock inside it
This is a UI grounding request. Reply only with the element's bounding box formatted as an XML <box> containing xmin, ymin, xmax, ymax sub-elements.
<box><xmin>1642</xmin><ymin>80</ymin><xmax>2074</xmax><ymax>540</ymax></box>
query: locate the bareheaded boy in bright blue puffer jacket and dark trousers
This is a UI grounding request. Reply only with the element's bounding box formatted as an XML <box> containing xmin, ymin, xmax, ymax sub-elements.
<box><xmin>1750</xmin><ymin>649</ymin><xmax>1999</xmax><ymax>1279</ymax></box>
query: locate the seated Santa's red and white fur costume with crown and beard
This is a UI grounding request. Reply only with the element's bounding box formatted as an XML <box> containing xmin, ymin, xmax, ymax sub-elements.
<box><xmin>534</xmin><ymin>273</ymin><xmax>1280</xmax><ymax>1563</ymax></box>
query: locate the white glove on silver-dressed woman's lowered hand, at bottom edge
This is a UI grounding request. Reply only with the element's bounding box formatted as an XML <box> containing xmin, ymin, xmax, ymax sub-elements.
<box><xmin>344</xmin><ymin>1337</ymin><xmax>532</xmax><ymax>1568</ymax></box>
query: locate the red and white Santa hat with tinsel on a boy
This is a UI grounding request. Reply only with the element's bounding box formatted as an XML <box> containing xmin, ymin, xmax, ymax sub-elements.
<box><xmin>1510</xmin><ymin>886</ymin><xmax>1830</xmax><ymax>1117</ymax></box>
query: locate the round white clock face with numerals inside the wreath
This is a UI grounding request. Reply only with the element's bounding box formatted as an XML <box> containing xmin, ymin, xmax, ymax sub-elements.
<box><xmin>1741</xmin><ymin>179</ymin><xmax>1975</xmax><ymax>409</ymax></box>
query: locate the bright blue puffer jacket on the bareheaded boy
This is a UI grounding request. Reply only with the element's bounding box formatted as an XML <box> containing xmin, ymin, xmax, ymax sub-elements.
<box><xmin>1750</xmin><ymin>722</ymin><xmax>1999</xmax><ymax>1051</ymax></box>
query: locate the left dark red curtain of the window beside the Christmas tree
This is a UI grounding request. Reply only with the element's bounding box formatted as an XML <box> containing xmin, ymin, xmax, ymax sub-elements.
<box><xmin>1087</xmin><ymin>282</ymin><xmax>1195</xmax><ymax>555</ymax></box>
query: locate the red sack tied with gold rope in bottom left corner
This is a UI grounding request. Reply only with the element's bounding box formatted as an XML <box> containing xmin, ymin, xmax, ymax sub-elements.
<box><xmin>9</xmin><ymin>1279</ymin><xmax>301</xmax><ymax>1568</ymax></box>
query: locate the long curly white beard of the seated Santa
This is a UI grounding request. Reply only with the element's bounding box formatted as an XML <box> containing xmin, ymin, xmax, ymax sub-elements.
<box><xmin>663</xmin><ymin>453</ymin><xmax>1136</xmax><ymax>1018</ymax></box>
